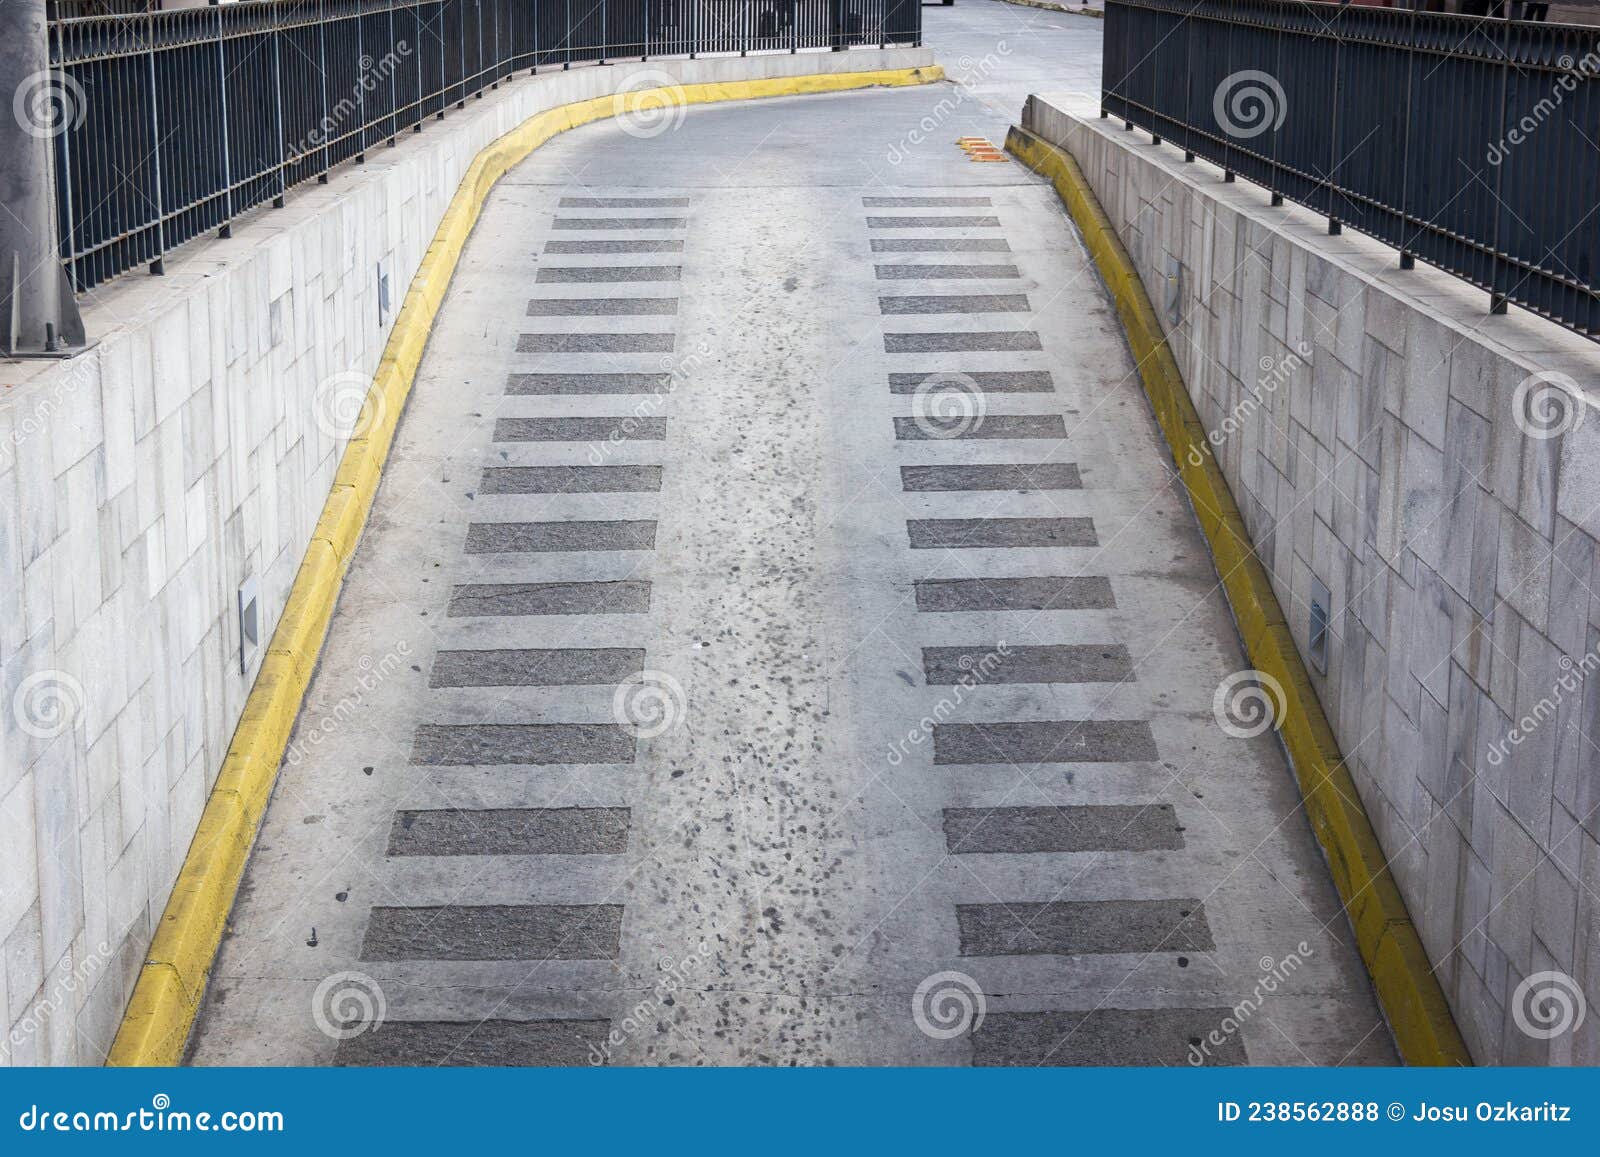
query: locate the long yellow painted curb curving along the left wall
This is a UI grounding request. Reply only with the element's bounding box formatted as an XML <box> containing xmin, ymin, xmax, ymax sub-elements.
<box><xmin>106</xmin><ymin>58</ymin><xmax>944</xmax><ymax>1066</ymax></box>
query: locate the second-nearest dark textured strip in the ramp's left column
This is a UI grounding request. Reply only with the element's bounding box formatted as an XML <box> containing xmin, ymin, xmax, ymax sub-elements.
<box><xmin>362</xmin><ymin>904</ymin><xmax>622</xmax><ymax>960</ymax></box>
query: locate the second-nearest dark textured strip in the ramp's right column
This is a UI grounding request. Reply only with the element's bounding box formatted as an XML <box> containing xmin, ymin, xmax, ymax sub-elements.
<box><xmin>955</xmin><ymin>899</ymin><xmax>1214</xmax><ymax>955</ymax></box>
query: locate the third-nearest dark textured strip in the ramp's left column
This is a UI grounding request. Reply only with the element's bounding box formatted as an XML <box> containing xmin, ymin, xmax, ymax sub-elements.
<box><xmin>389</xmin><ymin>808</ymin><xmax>630</xmax><ymax>856</ymax></box>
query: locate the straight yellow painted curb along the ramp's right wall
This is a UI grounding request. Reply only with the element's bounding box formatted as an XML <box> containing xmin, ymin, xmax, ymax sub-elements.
<box><xmin>1006</xmin><ymin>126</ymin><xmax>1472</xmax><ymax>1064</ymax></box>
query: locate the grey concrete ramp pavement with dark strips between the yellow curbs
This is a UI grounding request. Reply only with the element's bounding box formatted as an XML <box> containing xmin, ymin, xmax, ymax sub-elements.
<box><xmin>192</xmin><ymin>5</ymin><xmax>1392</xmax><ymax>1064</ymax></box>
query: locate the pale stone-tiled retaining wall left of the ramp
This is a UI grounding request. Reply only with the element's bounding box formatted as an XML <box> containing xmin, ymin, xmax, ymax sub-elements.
<box><xmin>0</xmin><ymin>50</ymin><xmax>933</xmax><ymax>1064</ymax></box>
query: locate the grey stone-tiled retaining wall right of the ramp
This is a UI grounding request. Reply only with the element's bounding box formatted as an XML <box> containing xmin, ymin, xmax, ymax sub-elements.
<box><xmin>1024</xmin><ymin>98</ymin><xmax>1600</xmax><ymax>1064</ymax></box>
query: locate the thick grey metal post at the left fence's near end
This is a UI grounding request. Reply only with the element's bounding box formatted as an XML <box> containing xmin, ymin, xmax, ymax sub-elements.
<box><xmin>0</xmin><ymin>0</ymin><xmax>83</xmax><ymax>357</ymax></box>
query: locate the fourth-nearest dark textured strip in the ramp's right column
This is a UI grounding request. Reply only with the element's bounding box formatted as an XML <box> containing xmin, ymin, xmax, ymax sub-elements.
<box><xmin>933</xmin><ymin>719</ymin><xmax>1157</xmax><ymax>763</ymax></box>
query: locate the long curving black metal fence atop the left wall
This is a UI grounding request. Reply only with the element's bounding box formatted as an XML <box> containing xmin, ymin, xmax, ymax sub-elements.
<box><xmin>50</xmin><ymin>0</ymin><xmax>922</xmax><ymax>291</ymax></box>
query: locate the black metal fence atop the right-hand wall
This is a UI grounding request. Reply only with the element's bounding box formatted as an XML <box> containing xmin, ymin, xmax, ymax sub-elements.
<box><xmin>1101</xmin><ymin>0</ymin><xmax>1600</xmax><ymax>336</ymax></box>
